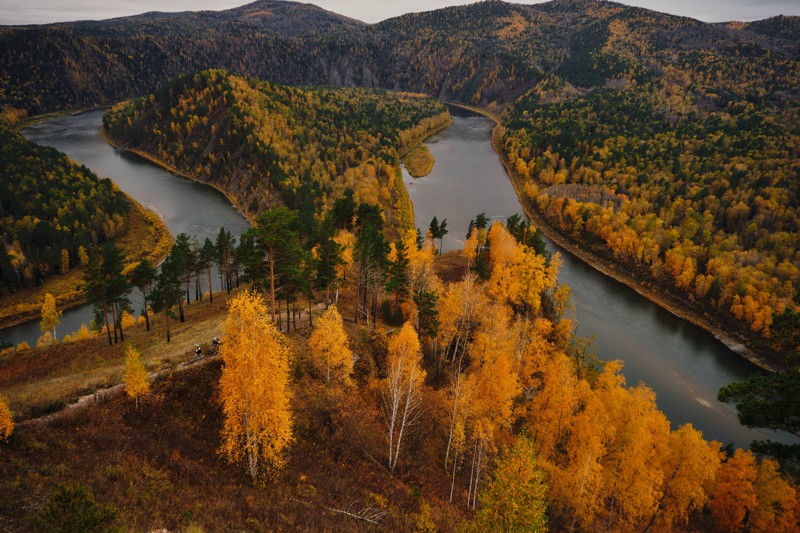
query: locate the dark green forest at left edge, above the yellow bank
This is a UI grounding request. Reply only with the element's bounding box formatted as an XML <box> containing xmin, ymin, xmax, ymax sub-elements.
<box><xmin>0</xmin><ymin>128</ymin><xmax>129</xmax><ymax>295</ymax></box>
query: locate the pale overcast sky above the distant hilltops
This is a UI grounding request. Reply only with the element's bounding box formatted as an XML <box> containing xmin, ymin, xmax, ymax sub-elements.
<box><xmin>0</xmin><ymin>0</ymin><xmax>800</xmax><ymax>24</ymax></box>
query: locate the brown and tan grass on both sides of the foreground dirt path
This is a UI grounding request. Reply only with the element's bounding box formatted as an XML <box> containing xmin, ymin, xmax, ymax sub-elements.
<box><xmin>0</xmin><ymin>276</ymin><xmax>468</xmax><ymax>532</ymax></box>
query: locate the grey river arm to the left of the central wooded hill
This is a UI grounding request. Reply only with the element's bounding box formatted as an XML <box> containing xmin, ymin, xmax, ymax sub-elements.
<box><xmin>0</xmin><ymin>110</ymin><xmax>249</xmax><ymax>345</ymax></box>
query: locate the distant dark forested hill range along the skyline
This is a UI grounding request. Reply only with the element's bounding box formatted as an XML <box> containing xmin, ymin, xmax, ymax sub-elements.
<box><xmin>0</xmin><ymin>0</ymin><xmax>800</xmax><ymax>113</ymax></box>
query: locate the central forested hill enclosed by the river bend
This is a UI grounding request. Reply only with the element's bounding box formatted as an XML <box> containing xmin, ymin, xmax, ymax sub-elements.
<box><xmin>104</xmin><ymin>70</ymin><xmax>450</xmax><ymax>224</ymax></box>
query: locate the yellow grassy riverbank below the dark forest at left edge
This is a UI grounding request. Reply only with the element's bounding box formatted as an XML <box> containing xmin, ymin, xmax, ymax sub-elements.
<box><xmin>0</xmin><ymin>193</ymin><xmax>174</xmax><ymax>330</ymax></box>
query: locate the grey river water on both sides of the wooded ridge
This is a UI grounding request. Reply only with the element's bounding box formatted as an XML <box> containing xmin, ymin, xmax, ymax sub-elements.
<box><xmin>2</xmin><ymin>106</ymin><xmax>794</xmax><ymax>447</ymax></box>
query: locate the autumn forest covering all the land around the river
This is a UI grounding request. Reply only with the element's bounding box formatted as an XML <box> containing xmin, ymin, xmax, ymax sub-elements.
<box><xmin>0</xmin><ymin>0</ymin><xmax>800</xmax><ymax>532</ymax></box>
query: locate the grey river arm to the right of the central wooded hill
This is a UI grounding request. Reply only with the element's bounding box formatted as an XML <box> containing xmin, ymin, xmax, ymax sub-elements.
<box><xmin>403</xmin><ymin>108</ymin><xmax>797</xmax><ymax>447</ymax></box>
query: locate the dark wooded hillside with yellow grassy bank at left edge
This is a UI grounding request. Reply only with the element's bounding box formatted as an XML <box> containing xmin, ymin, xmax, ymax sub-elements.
<box><xmin>0</xmin><ymin>127</ymin><xmax>171</xmax><ymax>324</ymax></box>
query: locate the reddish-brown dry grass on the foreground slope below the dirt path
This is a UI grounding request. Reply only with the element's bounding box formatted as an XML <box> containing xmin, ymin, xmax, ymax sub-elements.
<box><xmin>0</xmin><ymin>299</ymin><xmax>465</xmax><ymax>531</ymax></box>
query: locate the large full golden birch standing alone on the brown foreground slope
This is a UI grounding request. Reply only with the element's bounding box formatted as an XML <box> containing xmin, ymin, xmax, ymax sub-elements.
<box><xmin>220</xmin><ymin>292</ymin><xmax>292</xmax><ymax>480</ymax></box>
